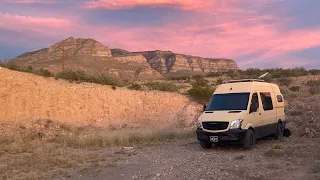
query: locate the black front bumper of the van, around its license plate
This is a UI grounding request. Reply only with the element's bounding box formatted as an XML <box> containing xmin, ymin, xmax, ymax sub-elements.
<box><xmin>196</xmin><ymin>128</ymin><xmax>247</xmax><ymax>142</ymax></box>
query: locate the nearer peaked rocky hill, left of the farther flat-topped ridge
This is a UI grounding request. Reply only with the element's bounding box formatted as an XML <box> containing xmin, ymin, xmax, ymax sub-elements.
<box><xmin>10</xmin><ymin>37</ymin><xmax>162</xmax><ymax>79</ymax></box>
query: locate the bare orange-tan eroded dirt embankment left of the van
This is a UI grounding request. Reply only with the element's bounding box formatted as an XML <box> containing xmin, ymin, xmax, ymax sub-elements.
<box><xmin>0</xmin><ymin>68</ymin><xmax>201</xmax><ymax>127</ymax></box>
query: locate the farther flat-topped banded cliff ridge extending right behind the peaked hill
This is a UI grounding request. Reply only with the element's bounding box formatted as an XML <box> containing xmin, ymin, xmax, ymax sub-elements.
<box><xmin>135</xmin><ymin>51</ymin><xmax>238</xmax><ymax>74</ymax></box>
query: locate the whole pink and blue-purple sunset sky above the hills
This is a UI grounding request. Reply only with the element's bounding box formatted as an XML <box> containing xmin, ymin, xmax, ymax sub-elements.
<box><xmin>0</xmin><ymin>0</ymin><xmax>320</xmax><ymax>69</ymax></box>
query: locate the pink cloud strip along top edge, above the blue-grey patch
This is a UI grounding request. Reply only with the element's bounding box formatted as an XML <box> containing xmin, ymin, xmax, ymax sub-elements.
<box><xmin>85</xmin><ymin>0</ymin><xmax>214</xmax><ymax>10</ymax></box>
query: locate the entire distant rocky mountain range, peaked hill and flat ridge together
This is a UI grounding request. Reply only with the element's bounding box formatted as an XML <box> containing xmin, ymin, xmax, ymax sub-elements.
<box><xmin>9</xmin><ymin>37</ymin><xmax>238</xmax><ymax>79</ymax></box>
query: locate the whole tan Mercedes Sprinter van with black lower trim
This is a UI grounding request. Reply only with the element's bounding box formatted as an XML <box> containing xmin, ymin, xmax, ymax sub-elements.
<box><xmin>196</xmin><ymin>79</ymin><xmax>286</xmax><ymax>149</ymax></box>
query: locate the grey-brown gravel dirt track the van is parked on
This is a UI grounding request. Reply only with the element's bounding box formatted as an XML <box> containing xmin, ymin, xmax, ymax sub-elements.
<box><xmin>60</xmin><ymin>137</ymin><xmax>320</xmax><ymax>180</ymax></box>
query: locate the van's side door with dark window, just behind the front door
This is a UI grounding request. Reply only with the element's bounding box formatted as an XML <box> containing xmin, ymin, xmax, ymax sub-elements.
<box><xmin>259</xmin><ymin>92</ymin><xmax>277</xmax><ymax>136</ymax></box>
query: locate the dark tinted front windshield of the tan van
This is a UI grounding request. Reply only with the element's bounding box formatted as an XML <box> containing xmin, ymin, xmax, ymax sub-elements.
<box><xmin>206</xmin><ymin>93</ymin><xmax>250</xmax><ymax>111</ymax></box>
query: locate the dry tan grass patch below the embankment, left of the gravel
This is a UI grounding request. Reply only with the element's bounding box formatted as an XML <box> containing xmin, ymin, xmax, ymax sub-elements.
<box><xmin>0</xmin><ymin>120</ymin><xmax>194</xmax><ymax>179</ymax></box>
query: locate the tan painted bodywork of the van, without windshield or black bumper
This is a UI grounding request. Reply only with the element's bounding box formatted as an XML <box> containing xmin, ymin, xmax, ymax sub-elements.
<box><xmin>198</xmin><ymin>81</ymin><xmax>286</xmax><ymax>138</ymax></box>
